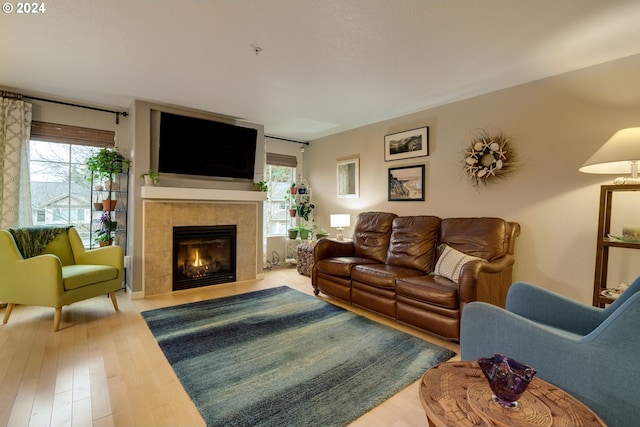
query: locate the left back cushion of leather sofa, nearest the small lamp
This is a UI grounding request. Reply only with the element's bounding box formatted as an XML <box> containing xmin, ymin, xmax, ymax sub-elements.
<box><xmin>353</xmin><ymin>212</ymin><xmax>397</xmax><ymax>263</ymax></box>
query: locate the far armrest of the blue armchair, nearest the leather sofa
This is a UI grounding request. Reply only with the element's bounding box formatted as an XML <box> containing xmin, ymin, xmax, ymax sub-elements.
<box><xmin>506</xmin><ymin>282</ymin><xmax>606</xmax><ymax>335</ymax></box>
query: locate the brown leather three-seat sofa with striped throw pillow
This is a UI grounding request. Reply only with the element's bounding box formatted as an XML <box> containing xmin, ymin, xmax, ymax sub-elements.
<box><xmin>311</xmin><ymin>212</ymin><xmax>520</xmax><ymax>340</ymax></box>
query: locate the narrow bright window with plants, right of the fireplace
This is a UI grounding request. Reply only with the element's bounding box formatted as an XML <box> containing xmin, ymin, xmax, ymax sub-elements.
<box><xmin>265</xmin><ymin>164</ymin><xmax>296</xmax><ymax>236</ymax></box>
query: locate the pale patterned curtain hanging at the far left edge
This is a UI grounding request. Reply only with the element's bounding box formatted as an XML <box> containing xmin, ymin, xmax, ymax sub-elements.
<box><xmin>0</xmin><ymin>91</ymin><xmax>33</xmax><ymax>229</ymax></box>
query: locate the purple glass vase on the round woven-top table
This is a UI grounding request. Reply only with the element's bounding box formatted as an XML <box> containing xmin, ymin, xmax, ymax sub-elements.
<box><xmin>478</xmin><ymin>354</ymin><xmax>536</xmax><ymax>408</ymax></box>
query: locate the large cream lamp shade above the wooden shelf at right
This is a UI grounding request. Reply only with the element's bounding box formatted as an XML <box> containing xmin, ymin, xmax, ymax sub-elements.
<box><xmin>579</xmin><ymin>127</ymin><xmax>640</xmax><ymax>178</ymax></box>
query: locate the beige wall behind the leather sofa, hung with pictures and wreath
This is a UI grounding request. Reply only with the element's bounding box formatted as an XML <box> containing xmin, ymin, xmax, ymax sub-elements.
<box><xmin>305</xmin><ymin>56</ymin><xmax>640</xmax><ymax>303</ymax></box>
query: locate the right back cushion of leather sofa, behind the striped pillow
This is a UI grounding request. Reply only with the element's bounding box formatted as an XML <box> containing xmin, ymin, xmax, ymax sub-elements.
<box><xmin>440</xmin><ymin>218</ymin><xmax>510</xmax><ymax>261</ymax></box>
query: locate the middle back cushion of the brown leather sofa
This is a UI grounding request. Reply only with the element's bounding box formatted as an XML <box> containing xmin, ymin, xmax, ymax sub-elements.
<box><xmin>387</xmin><ymin>216</ymin><xmax>440</xmax><ymax>273</ymax></box>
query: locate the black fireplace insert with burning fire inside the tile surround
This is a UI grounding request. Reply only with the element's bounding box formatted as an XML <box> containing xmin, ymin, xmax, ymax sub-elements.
<box><xmin>173</xmin><ymin>225</ymin><xmax>236</xmax><ymax>291</ymax></box>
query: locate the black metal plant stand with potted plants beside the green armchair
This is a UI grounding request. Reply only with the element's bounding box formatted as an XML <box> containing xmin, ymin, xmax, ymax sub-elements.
<box><xmin>89</xmin><ymin>171</ymin><xmax>129</xmax><ymax>254</ymax></box>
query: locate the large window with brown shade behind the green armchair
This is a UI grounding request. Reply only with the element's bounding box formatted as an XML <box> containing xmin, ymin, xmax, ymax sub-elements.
<box><xmin>29</xmin><ymin>121</ymin><xmax>114</xmax><ymax>246</ymax></box>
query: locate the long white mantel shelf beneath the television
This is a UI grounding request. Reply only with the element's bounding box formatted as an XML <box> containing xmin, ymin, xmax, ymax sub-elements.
<box><xmin>140</xmin><ymin>185</ymin><xmax>267</xmax><ymax>202</ymax></box>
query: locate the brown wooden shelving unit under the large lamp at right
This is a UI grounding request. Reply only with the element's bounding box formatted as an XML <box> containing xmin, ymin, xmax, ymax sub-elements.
<box><xmin>593</xmin><ymin>185</ymin><xmax>640</xmax><ymax>307</ymax></box>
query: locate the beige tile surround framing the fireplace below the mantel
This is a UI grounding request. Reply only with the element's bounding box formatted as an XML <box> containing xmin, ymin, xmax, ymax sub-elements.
<box><xmin>142</xmin><ymin>187</ymin><xmax>264</xmax><ymax>296</ymax></box>
